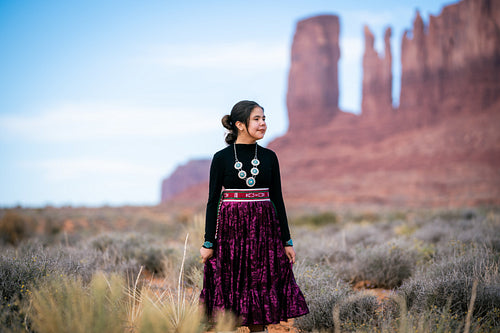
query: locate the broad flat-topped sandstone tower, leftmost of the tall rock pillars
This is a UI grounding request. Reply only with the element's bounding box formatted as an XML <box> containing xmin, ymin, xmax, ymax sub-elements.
<box><xmin>287</xmin><ymin>15</ymin><xmax>340</xmax><ymax>130</ymax></box>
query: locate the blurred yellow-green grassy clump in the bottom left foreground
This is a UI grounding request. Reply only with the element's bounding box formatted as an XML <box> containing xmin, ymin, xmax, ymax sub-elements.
<box><xmin>30</xmin><ymin>274</ymin><xmax>127</xmax><ymax>333</ymax></box>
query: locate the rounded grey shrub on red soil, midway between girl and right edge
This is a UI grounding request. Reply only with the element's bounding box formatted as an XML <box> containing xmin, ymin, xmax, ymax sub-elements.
<box><xmin>342</xmin><ymin>243</ymin><xmax>416</xmax><ymax>289</ymax></box>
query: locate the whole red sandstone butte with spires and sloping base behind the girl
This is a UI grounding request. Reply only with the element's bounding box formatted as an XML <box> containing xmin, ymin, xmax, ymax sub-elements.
<box><xmin>161</xmin><ymin>0</ymin><xmax>500</xmax><ymax>209</ymax></box>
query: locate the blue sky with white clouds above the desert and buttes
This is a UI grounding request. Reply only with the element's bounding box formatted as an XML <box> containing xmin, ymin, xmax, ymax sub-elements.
<box><xmin>0</xmin><ymin>0</ymin><xmax>456</xmax><ymax>207</ymax></box>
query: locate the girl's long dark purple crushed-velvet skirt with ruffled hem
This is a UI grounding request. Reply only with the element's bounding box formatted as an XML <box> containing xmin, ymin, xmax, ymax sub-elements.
<box><xmin>200</xmin><ymin>189</ymin><xmax>309</xmax><ymax>326</ymax></box>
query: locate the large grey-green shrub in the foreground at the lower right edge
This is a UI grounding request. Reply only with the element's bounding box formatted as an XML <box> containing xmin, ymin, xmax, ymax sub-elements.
<box><xmin>399</xmin><ymin>243</ymin><xmax>500</xmax><ymax>325</ymax></box>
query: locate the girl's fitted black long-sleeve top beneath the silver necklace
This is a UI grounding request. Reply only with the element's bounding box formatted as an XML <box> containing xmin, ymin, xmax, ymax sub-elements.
<box><xmin>205</xmin><ymin>143</ymin><xmax>290</xmax><ymax>243</ymax></box>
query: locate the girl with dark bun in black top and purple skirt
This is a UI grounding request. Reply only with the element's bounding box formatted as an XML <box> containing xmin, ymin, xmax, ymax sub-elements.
<box><xmin>200</xmin><ymin>101</ymin><xmax>309</xmax><ymax>332</ymax></box>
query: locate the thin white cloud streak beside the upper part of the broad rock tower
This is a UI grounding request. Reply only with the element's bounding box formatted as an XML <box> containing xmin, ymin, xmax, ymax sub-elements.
<box><xmin>147</xmin><ymin>42</ymin><xmax>289</xmax><ymax>70</ymax></box>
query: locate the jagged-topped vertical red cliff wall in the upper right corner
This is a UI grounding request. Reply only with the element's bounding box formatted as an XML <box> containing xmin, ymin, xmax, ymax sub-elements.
<box><xmin>400</xmin><ymin>0</ymin><xmax>500</xmax><ymax>116</ymax></box>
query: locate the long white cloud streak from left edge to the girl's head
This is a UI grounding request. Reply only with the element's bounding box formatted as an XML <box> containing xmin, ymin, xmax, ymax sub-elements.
<box><xmin>0</xmin><ymin>103</ymin><xmax>220</xmax><ymax>142</ymax></box>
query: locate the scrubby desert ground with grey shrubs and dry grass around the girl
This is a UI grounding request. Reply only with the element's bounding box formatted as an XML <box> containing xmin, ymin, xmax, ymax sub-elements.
<box><xmin>0</xmin><ymin>205</ymin><xmax>500</xmax><ymax>332</ymax></box>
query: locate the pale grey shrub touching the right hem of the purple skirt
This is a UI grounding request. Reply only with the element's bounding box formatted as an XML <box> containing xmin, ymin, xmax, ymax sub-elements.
<box><xmin>294</xmin><ymin>263</ymin><xmax>354</xmax><ymax>331</ymax></box>
